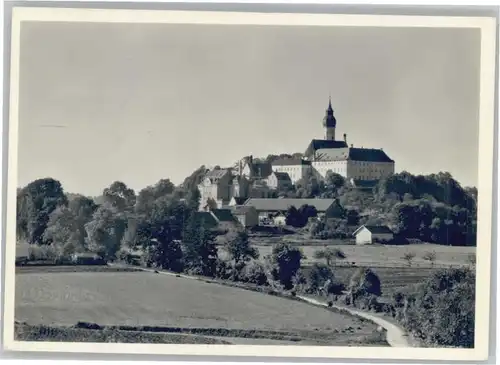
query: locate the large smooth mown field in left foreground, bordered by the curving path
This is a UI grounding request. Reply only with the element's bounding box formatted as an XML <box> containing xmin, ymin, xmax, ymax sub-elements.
<box><xmin>15</xmin><ymin>268</ymin><xmax>382</xmax><ymax>346</ymax></box>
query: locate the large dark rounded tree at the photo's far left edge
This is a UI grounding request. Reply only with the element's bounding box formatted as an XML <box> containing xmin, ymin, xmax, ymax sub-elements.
<box><xmin>17</xmin><ymin>178</ymin><xmax>67</xmax><ymax>244</ymax></box>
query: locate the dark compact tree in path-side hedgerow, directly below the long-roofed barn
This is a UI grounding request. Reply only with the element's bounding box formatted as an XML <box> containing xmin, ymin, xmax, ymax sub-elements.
<box><xmin>271</xmin><ymin>243</ymin><xmax>303</xmax><ymax>290</ymax></box>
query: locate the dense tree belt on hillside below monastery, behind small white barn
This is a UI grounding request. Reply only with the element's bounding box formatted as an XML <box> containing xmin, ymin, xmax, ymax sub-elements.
<box><xmin>268</xmin><ymin>171</ymin><xmax>477</xmax><ymax>246</ymax></box>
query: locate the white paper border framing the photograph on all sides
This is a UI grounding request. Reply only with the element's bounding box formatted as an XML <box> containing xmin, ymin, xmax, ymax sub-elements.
<box><xmin>3</xmin><ymin>7</ymin><xmax>496</xmax><ymax>361</ymax></box>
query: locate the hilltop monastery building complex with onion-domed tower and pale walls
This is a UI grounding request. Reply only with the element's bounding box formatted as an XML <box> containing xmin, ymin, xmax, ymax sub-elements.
<box><xmin>198</xmin><ymin>96</ymin><xmax>394</xmax><ymax>210</ymax></box>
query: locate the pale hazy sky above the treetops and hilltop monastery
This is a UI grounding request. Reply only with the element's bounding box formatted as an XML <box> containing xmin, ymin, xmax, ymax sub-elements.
<box><xmin>19</xmin><ymin>23</ymin><xmax>480</xmax><ymax>195</ymax></box>
